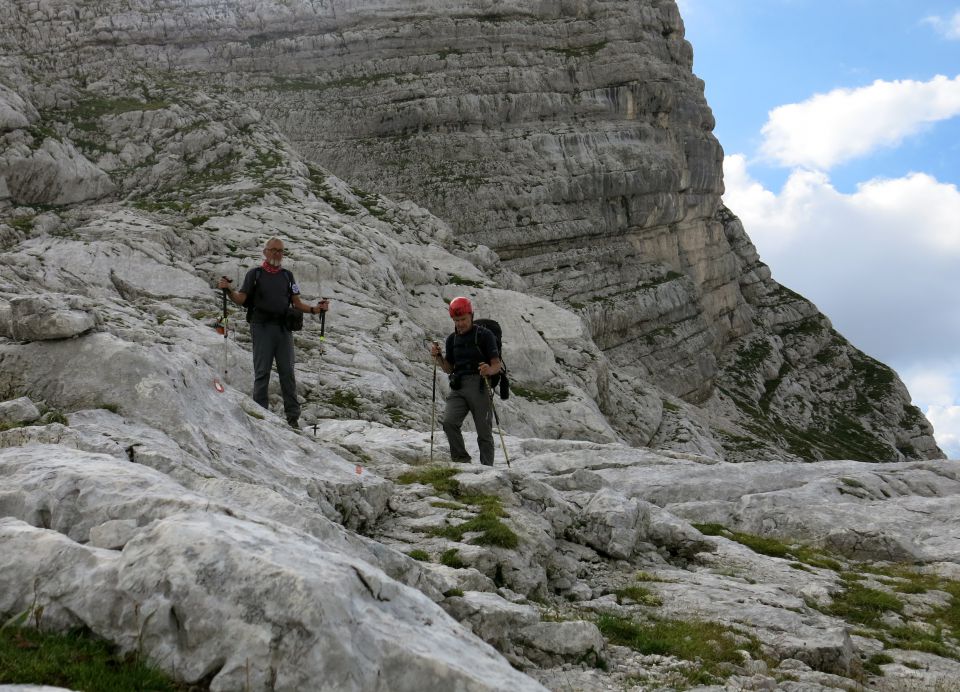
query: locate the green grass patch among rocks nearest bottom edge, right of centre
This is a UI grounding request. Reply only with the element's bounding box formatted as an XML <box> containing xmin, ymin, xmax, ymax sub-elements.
<box><xmin>597</xmin><ymin>615</ymin><xmax>764</xmax><ymax>685</ymax></box>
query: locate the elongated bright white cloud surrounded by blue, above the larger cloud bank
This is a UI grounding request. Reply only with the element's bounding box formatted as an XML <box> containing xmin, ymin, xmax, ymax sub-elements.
<box><xmin>761</xmin><ymin>75</ymin><xmax>960</xmax><ymax>170</ymax></box>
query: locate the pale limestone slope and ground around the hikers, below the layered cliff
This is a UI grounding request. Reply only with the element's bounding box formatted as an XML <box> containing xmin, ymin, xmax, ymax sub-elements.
<box><xmin>0</xmin><ymin>3</ymin><xmax>960</xmax><ymax>691</ymax></box>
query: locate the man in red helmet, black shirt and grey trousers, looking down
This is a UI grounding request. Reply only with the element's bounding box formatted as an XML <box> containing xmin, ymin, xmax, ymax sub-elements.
<box><xmin>430</xmin><ymin>296</ymin><xmax>501</xmax><ymax>466</ymax></box>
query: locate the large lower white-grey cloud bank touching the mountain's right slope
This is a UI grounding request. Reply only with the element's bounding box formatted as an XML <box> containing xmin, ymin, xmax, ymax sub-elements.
<box><xmin>723</xmin><ymin>159</ymin><xmax>960</xmax><ymax>459</ymax></box>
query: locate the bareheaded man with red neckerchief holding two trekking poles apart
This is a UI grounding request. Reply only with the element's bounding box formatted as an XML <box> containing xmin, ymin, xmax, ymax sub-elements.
<box><xmin>217</xmin><ymin>238</ymin><xmax>330</xmax><ymax>428</ymax></box>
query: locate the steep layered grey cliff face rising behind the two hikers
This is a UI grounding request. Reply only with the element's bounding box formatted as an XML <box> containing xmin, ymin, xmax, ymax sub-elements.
<box><xmin>0</xmin><ymin>0</ymin><xmax>940</xmax><ymax>459</ymax></box>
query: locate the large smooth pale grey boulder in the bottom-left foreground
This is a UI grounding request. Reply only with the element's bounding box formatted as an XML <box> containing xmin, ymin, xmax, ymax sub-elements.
<box><xmin>0</xmin><ymin>514</ymin><xmax>543</xmax><ymax>691</ymax></box>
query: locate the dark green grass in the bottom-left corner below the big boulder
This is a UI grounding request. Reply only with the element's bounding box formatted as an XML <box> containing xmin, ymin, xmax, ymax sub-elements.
<box><xmin>0</xmin><ymin>627</ymin><xmax>188</xmax><ymax>692</ymax></box>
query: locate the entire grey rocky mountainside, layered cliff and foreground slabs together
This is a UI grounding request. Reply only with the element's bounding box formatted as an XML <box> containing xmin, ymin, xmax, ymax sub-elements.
<box><xmin>0</xmin><ymin>0</ymin><xmax>960</xmax><ymax>690</ymax></box>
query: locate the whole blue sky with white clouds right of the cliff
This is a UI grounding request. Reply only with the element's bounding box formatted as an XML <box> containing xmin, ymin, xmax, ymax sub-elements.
<box><xmin>678</xmin><ymin>0</ymin><xmax>960</xmax><ymax>459</ymax></box>
